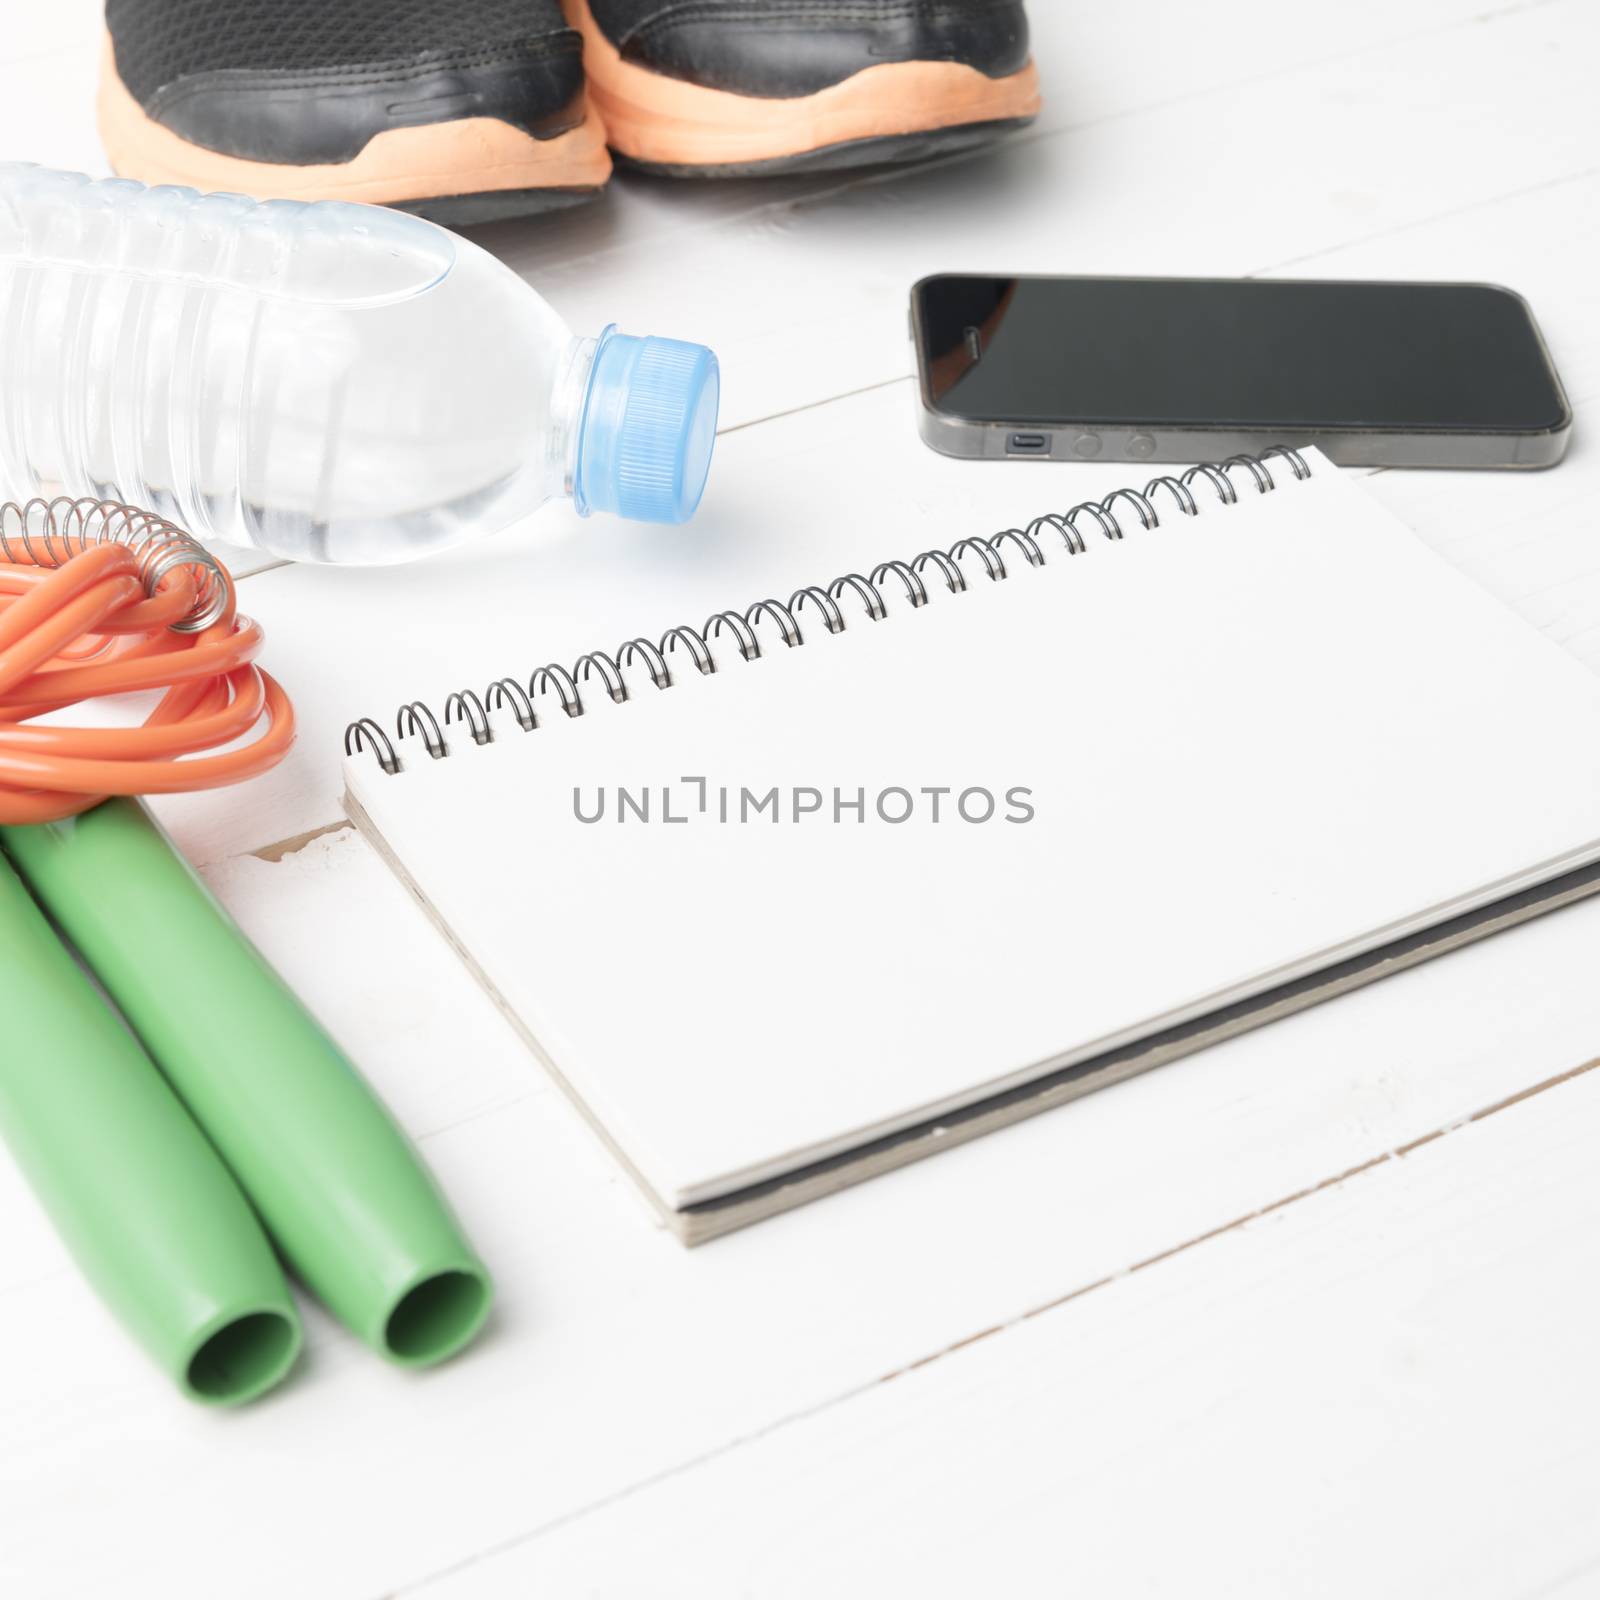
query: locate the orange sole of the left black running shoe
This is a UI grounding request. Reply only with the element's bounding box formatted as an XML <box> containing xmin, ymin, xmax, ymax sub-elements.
<box><xmin>96</xmin><ymin>35</ymin><xmax>611</xmax><ymax>222</ymax></box>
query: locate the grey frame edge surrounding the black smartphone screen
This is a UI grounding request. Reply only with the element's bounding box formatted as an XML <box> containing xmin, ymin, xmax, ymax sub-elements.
<box><xmin>910</xmin><ymin>272</ymin><xmax>1573</xmax><ymax>469</ymax></box>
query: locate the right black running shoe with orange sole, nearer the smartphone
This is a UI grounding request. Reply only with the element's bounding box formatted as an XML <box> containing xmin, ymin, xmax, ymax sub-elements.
<box><xmin>566</xmin><ymin>0</ymin><xmax>1038</xmax><ymax>178</ymax></box>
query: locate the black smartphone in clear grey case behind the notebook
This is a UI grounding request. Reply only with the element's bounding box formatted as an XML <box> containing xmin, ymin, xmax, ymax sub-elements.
<box><xmin>910</xmin><ymin>274</ymin><xmax>1573</xmax><ymax>467</ymax></box>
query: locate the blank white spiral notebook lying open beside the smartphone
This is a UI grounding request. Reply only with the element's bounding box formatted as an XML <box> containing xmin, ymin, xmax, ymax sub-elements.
<box><xmin>346</xmin><ymin>451</ymin><xmax>1600</xmax><ymax>1243</ymax></box>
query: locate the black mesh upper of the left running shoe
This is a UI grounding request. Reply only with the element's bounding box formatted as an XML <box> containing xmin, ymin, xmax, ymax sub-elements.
<box><xmin>106</xmin><ymin>0</ymin><xmax>566</xmax><ymax>101</ymax></box>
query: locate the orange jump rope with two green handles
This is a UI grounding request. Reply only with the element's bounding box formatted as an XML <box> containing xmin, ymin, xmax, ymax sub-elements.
<box><xmin>0</xmin><ymin>499</ymin><xmax>491</xmax><ymax>1403</ymax></box>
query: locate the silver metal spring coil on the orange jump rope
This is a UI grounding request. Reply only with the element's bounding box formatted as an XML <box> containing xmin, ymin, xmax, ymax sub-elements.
<box><xmin>0</xmin><ymin>494</ymin><xmax>232</xmax><ymax>634</ymax></box>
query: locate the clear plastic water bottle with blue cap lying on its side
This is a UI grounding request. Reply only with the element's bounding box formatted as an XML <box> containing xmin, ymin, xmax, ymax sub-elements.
<box><xmin>0</xmin><ymin>163</ymin><xmax>718</xmax><ymax>563</ymax></box>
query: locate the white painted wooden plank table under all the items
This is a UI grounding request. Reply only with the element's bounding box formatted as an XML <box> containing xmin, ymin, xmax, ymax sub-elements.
<box><xmin>0</xmin><ymin>0</ymin><xmax>1600</xmax><ymax>1600</ymax></box>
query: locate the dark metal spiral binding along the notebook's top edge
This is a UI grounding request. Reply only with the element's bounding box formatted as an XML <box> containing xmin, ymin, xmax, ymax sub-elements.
<box><xmin>344</xmin><ymin>445</ymin><xmax>1310</xmax><ymax>773</ymax></box>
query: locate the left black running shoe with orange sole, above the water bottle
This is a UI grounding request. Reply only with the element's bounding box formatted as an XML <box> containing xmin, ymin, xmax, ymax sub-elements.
<box><xmin>99</xmin><ymin>0</ymin><xmax>611</xmax><ymax>222</ymax></box>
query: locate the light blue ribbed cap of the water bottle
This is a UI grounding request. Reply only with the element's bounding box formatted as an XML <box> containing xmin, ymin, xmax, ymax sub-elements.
<box><xmin>573</xmin><ymin>328</ymin><xmax>722</xmax><ymax>523</ymax></box>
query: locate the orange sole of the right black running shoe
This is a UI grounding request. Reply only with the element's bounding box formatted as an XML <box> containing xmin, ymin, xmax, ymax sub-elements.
<box><xmin>563</xmin><ymin>0</ymin><xmax>1040</xmax><ymax>176</ymax></box>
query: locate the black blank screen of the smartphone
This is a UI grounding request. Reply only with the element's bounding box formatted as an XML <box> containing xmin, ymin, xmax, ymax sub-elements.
<box><xmin>915</xmin><ymin>277</ymin><xmax>1566</xmax><ymax>432</ymax></box>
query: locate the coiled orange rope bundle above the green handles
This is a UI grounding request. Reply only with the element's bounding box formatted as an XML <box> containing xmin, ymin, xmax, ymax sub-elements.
<box><xmin>0</xmin><ymin>501</ymin><xmax>294</xmax><ymax>822</ymax></box>
